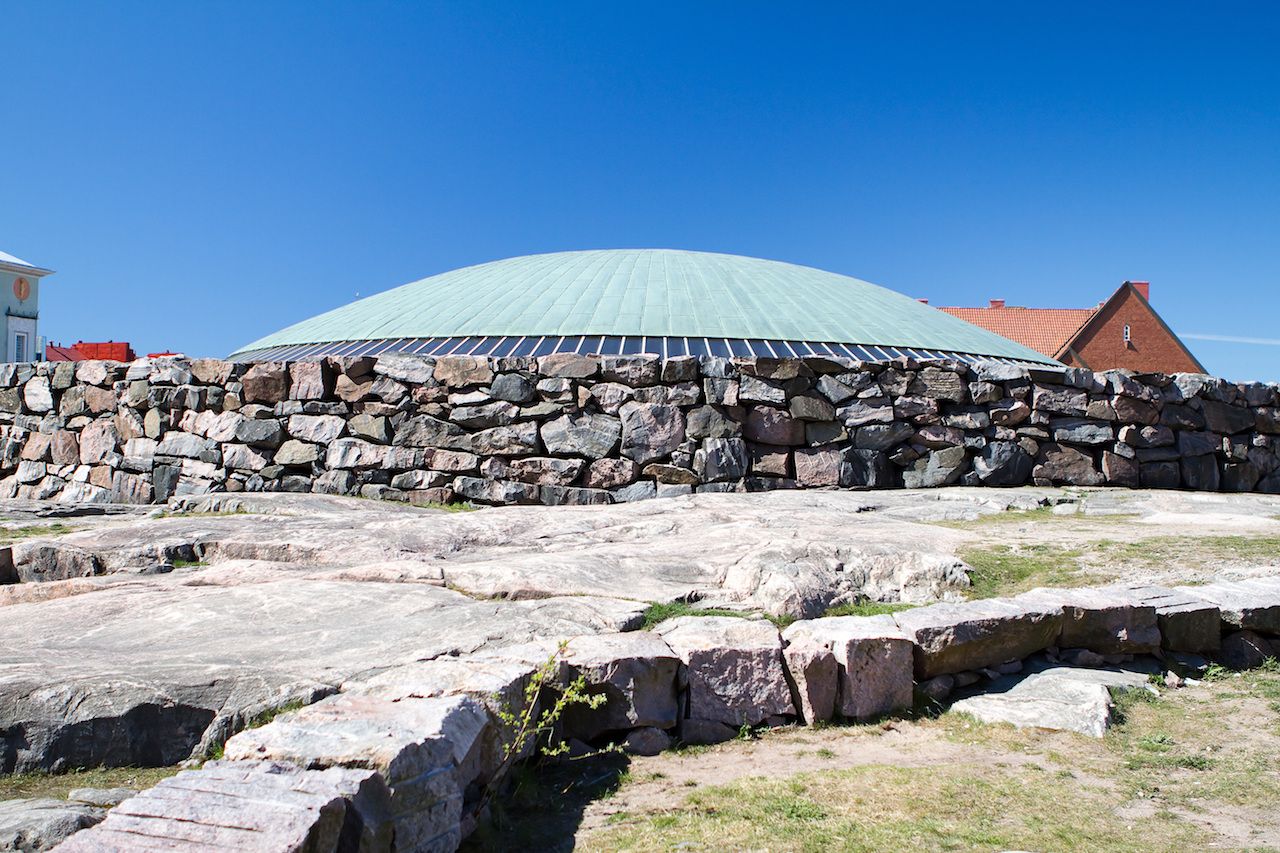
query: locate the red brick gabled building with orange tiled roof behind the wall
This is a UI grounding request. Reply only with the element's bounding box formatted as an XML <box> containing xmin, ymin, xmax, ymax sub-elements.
<box><xmin>941</xmin><ymin>282</ymin><xmax>1204</xmax><ymax>373</ymax></box>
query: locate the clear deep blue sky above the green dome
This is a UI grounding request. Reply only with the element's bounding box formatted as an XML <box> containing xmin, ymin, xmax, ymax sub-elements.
<box><xmin>0</xmin><ymin>1</ymin><xmax>1280</xmax><ymax>380</ymax></box>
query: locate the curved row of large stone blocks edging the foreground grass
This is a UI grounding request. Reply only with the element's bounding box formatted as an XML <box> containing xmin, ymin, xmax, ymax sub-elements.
<box><xmin>40</xmin><ymin>579</ymin><xmax>1280</xmax><ymax>852</ymax></box>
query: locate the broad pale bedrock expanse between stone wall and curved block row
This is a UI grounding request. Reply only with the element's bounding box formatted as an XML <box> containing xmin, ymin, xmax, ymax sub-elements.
<box><xmin>0</xmin><ymin>488</ymin><xmax>1280</xmax><ymax>845</ymax></box>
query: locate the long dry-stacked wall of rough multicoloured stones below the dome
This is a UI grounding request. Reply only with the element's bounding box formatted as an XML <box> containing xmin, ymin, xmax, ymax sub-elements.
<box><xmin>0</xmin><ymin>355</ymin><xmax>1280</xmax><ymax>503</ymax></box>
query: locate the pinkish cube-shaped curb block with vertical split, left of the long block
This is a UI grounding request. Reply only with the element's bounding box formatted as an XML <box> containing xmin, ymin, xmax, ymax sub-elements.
<box><xmin>782</xmin><ymin>616</ymin><xmax>914</xmax><ymax>721</ymax></box>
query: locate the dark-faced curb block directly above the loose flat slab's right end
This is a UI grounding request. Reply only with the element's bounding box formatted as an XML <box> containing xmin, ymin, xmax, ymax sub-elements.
<box><xmin>1014</xmin><ymin>587</ymin><xmax>1160</xmax><ymax>654</ymax></box>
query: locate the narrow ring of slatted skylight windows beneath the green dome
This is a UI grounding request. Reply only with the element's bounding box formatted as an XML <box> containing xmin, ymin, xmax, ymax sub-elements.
<box><xmin>225</xmin><ymin>334</ymin><xmax>1032</xmax><ymax>364</ymax></box>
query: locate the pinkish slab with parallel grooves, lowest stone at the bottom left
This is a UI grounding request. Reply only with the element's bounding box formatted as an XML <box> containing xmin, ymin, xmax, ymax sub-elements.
<box><xmin>58</xmin><ymin>761</ymin><xmax>393</xmax><ymax>853</ymax></box>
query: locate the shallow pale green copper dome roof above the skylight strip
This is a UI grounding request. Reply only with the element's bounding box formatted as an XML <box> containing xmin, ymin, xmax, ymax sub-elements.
<box><xmin>232</xmin><ymin>248</ymin><xmax>1046</xmax><ymax>362</ymax></box>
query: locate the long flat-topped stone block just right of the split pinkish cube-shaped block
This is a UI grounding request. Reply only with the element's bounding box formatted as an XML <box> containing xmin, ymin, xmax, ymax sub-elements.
<box><xmin>893</xmin><ymin>598</ymin><xmax>1062</xmax><ymax>681</ymax></box>
